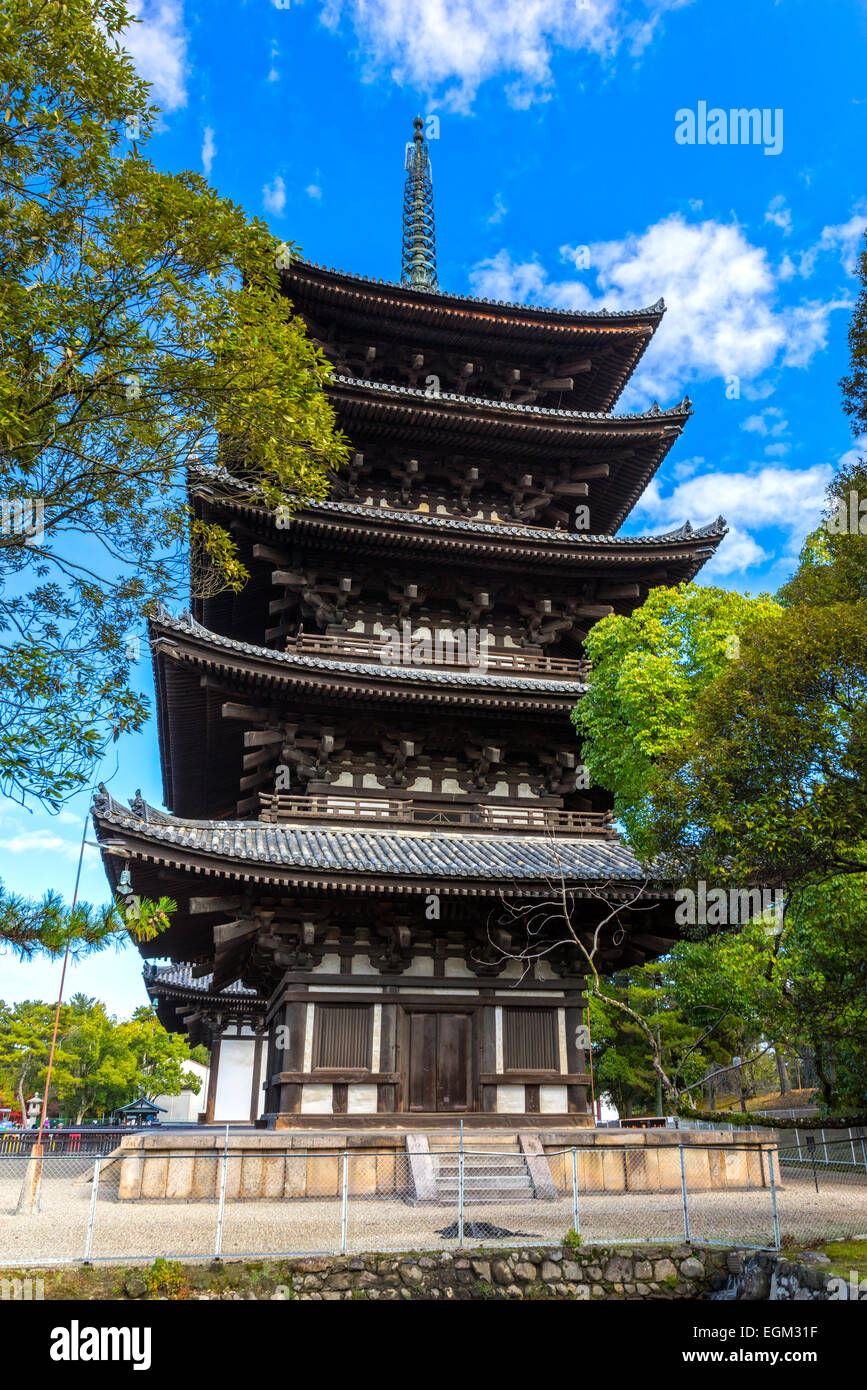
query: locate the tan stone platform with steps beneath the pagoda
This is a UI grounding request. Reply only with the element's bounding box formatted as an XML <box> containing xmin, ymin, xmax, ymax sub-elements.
<box><xmin>103</xmin><ymin>1127</ymin><xmax>779</xmax><ymax>1202</ymax></box>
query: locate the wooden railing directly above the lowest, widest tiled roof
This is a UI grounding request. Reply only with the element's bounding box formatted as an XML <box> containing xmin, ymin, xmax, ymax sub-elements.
<box><xmin>258</xmin><ymin>792</ymin><xmax>617</xmax><ymax>840</ymax></box>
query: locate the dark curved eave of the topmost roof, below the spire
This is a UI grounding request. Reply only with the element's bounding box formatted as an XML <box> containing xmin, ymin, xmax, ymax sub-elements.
<box><xmin>282</xmin><ymin>260</ymin><xmax>666</xmax><ymax>410</ymax></box>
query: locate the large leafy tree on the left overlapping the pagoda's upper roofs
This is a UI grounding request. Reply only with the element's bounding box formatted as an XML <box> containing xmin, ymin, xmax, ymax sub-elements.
<box><xmin>0</xmin><ymin>0</ymin><xmax>346</xmax><ymax>949</ymax></box>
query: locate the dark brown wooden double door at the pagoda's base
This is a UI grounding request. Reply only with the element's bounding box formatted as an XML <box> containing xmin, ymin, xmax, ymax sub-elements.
<box><xmin>407</xmin><ymin>1011</ymin><xmax>472</xmax><ymax>1115</ymax></box>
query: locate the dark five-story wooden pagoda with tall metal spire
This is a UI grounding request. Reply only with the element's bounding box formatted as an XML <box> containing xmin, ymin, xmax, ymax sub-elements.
<box><xmin>94</xmin><ymin>113</ymin><xmax>724</xmax><ymax>1127</ymax></box>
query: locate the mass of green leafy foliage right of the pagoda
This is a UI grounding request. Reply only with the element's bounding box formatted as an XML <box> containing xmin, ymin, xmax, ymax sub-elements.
<box><xmin>574</xmin><ymin>230</ymin><xmax>867</xmax><ymax>1111</ymax></box>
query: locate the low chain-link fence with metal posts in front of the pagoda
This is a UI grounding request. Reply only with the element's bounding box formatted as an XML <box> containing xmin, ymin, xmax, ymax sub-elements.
<box><xmin>0</xmin><ymin>1136</ymin><xmax>867</xmax><ymax>1266</ymax></box>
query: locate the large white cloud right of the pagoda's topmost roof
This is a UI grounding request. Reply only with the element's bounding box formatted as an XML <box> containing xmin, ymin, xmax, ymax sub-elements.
<box><xmin>470</xmin><ymin>213</ymin><xmax>849</xmax><ymax>404</ymax></box>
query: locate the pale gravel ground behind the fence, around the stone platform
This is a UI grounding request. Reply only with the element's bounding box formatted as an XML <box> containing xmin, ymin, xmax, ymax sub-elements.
<box><xmin>0</xmin><ymin>1159</ymin><xmax>867</xmax><ymax>1265</ymax></box>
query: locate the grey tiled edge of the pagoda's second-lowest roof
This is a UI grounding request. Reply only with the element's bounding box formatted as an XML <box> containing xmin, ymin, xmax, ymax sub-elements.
<box><xmin>156</xmin><ymin>607</ymin><xmax>586</xmax><ymax>696</ymax></box>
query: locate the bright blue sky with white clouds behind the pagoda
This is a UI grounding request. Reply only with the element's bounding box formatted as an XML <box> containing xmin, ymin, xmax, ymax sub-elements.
<box><xmin>0</xmin><ymin>0</ymin><xmax>867</xmax><ymax>1013</ymax></box>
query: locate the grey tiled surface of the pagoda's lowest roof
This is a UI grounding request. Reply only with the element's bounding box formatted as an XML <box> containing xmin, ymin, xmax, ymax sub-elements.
<box><xmin>93</xmin><ymin>792</ymin><xmax>655</xmax><ymax>891</ymax></box>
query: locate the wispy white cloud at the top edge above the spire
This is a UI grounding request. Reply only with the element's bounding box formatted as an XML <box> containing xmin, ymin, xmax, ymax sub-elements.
<box><xmin>321</xmin><ymin>0</ymin><xmax>691</xmax><ymax>111</ymax></box>
